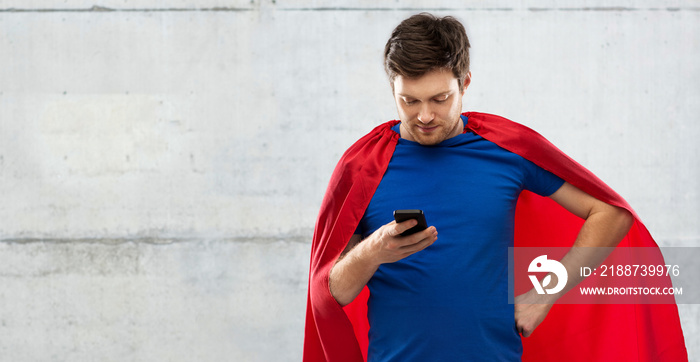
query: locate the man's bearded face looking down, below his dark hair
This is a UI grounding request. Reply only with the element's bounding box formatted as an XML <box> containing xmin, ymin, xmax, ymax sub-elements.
<box><xmin>394</xmin><ymin>69</ymin><xmax>471</xmax><ymax>145</ymax></box>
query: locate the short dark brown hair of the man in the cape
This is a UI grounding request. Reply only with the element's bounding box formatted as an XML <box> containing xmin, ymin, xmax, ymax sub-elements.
<box><xmin>384</xmin><ymin>13</ymin><xmax>469</xmax><ymax>90</ymax></box>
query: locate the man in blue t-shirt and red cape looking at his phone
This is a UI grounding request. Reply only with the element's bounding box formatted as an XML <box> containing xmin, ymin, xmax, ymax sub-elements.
<box><xmin>305</xmin><ymin>14</ymin><xmax>687</xmax><ymax>361</ymax></box>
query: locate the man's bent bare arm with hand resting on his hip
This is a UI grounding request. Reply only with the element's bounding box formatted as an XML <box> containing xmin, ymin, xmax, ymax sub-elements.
<box><xmin>515</xmin><ymin>182</ymin><xmax>634</xmax><ymax>337</ymax></box>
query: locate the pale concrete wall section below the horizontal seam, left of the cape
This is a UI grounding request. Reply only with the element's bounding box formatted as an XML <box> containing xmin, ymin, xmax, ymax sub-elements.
<box><xmin>0</xmin><ymin>240</ymin><xmax>308</xmax><ymax>361</ymax></box>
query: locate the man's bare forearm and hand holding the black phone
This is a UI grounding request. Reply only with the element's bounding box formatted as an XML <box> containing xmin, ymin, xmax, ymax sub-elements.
<box><xmin>328</xmin><ymin>220</ymin><xmax>437</xmax><ymax>306</ymax></box>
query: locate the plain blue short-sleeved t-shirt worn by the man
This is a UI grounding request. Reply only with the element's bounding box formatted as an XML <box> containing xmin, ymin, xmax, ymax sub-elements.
<box><xmin>358</xmin><ymin>116</ymin><xmax>564</xmax><ymax>362</ymax></box>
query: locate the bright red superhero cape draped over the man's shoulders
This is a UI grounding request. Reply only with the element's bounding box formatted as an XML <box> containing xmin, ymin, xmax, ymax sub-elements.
<box><xmin>304</xmin><ymin>112</ymin><xmax>688</xmax><ymax>362</ymax></box>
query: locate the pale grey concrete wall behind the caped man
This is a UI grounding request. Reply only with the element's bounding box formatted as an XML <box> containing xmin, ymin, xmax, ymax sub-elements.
<box><xmin>0</xmin><ymin>0</ymin><xmax>700</xmax><ymax>361</ymax></box>
